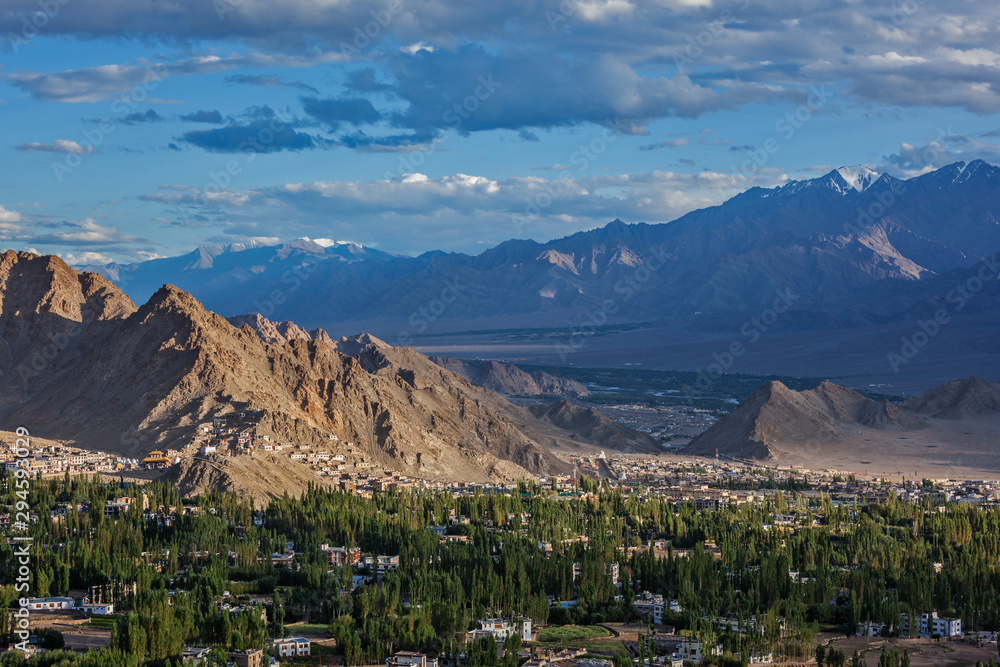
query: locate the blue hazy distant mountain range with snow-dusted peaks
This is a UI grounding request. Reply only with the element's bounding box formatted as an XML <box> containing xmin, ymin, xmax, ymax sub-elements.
<box><xmin>82</xmin><ymin>161</ymin><xmax>1000</xmax><ymax>343</ymax></box>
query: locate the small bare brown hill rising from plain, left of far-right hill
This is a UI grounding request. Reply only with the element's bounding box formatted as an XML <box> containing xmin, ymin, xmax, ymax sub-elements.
<box><xmin>685</xmin><ymin>382</ymin><xmax>924</xmax><ymax>460</ymax></box>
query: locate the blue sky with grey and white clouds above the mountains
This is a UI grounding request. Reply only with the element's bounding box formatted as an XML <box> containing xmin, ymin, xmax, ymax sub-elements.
<box><xmin>0</xmin><ymin>0</ymin><xmax>1000</xmax><ymax>264</ymax></box>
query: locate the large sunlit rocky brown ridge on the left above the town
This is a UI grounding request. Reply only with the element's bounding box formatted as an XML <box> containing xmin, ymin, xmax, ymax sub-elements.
<box><xmin>0</xmin><ymin>253</ymin><xmax>584</xmax><ymax>493</ymax></box>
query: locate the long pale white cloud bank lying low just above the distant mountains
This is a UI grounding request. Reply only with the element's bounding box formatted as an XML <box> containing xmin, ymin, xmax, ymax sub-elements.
<box><xmin>141</xmin><ymin>170</ymin><xmax>768</xmax><ymax>252</ymax></box>
